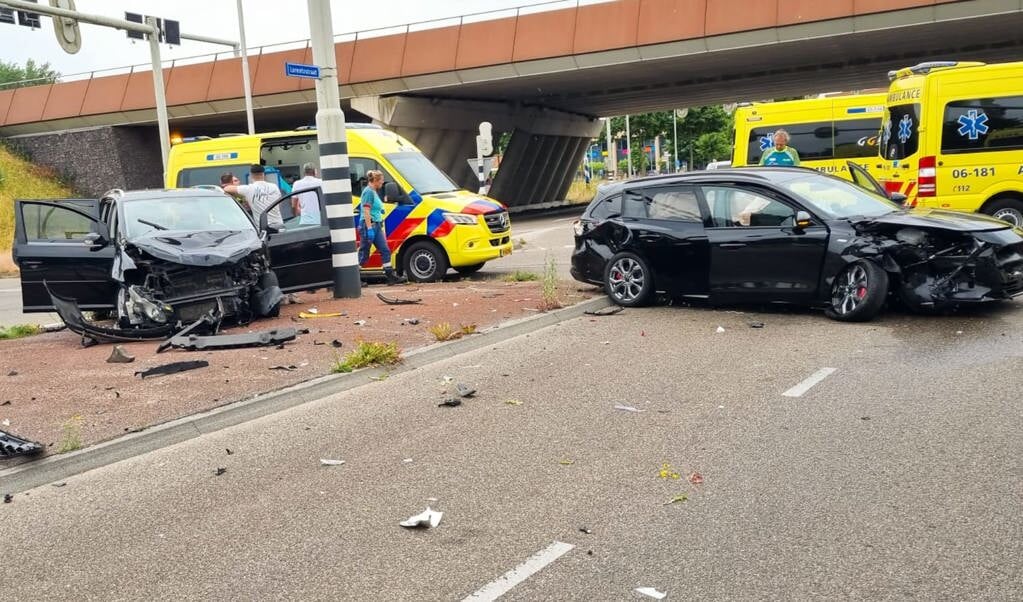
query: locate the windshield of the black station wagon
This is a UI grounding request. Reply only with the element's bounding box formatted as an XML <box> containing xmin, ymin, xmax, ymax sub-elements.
<box><xmin>779</xmin><ymin>174</ymin><xmax>899</xmax><ymax>219</ymax></box>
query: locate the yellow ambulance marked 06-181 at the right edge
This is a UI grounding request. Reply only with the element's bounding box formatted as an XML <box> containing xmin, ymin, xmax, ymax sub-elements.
<box><xmin>880</xmin><ymin>61</ymin><xmax>1023</xmax><ymax>226</ymax></box>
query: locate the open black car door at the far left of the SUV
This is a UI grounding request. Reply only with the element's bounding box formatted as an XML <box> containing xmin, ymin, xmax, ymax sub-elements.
<box><xmin>13</xmin><ymin>199</ymin><xmax>117</xmax><ymax>312</ymax></box>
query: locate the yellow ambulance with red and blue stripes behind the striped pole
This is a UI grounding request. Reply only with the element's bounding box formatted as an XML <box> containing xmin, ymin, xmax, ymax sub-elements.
<box><xmin>166</xmin><ymin>124</ymin><xmax>512</xmax><ymax>282</ymax></box>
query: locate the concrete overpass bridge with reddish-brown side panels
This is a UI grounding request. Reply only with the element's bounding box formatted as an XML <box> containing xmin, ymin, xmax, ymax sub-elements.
<box><xmin>0</xmin><ymin>0</ymin><xmax>1023</xmax><ymax>206</ymax></box>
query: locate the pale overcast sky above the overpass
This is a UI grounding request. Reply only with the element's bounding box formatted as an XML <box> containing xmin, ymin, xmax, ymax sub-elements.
<box><xmin>0</xmin><ymin>0</ymin><xmax>576</xmax><ymax>75</ymax></box>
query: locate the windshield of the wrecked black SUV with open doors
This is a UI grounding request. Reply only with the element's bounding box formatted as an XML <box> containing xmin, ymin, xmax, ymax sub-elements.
<box><xmin>124</xmin><ymin>195</ymin><xmax>255</xmax><ymax>239</ymax></box>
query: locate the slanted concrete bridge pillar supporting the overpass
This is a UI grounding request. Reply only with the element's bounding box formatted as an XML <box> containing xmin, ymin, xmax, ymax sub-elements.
<box><xmin>352</xmin><ymin>96</ymin><xmax>601</xmax><ymax>208</ymax></box>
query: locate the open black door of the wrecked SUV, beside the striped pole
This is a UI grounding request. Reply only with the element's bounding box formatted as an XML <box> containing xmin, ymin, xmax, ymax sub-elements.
<box><xmin>257</xmin><ymin>188</ymin><xmax>333</xmax><ymax>293</ymax></box>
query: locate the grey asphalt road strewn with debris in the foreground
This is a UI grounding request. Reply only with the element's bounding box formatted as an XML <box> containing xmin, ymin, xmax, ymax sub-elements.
<box><xmin>0</xmin><ymin>303</ymin><xmax>1023</xmax><ymax>600</ymax></box>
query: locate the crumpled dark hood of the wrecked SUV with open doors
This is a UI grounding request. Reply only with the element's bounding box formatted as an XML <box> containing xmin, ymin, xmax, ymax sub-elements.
<box><xmin>131</xmin><ymin>230</ymin><xmax>263</xmax><ymax>267</ymax></box>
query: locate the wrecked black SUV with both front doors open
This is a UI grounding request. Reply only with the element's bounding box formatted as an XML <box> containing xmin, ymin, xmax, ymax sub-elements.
<box><xmin>13</xmin><ymin>188</ymin><xmax>332</xmax><ymax>340</ymax></box>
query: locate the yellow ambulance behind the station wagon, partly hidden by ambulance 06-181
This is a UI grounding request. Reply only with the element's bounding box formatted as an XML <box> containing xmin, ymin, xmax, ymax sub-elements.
<box><xmin>731</xmin><ymin>93</ymin><xmax>885</xmax><ymax>179</ymax></box>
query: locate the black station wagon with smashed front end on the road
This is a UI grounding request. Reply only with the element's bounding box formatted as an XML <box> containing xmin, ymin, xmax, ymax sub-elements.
<box><xmin>572</xmin><ymin>164</ymin><xmax>1023</xmax><ymax>321</ymax></box>
